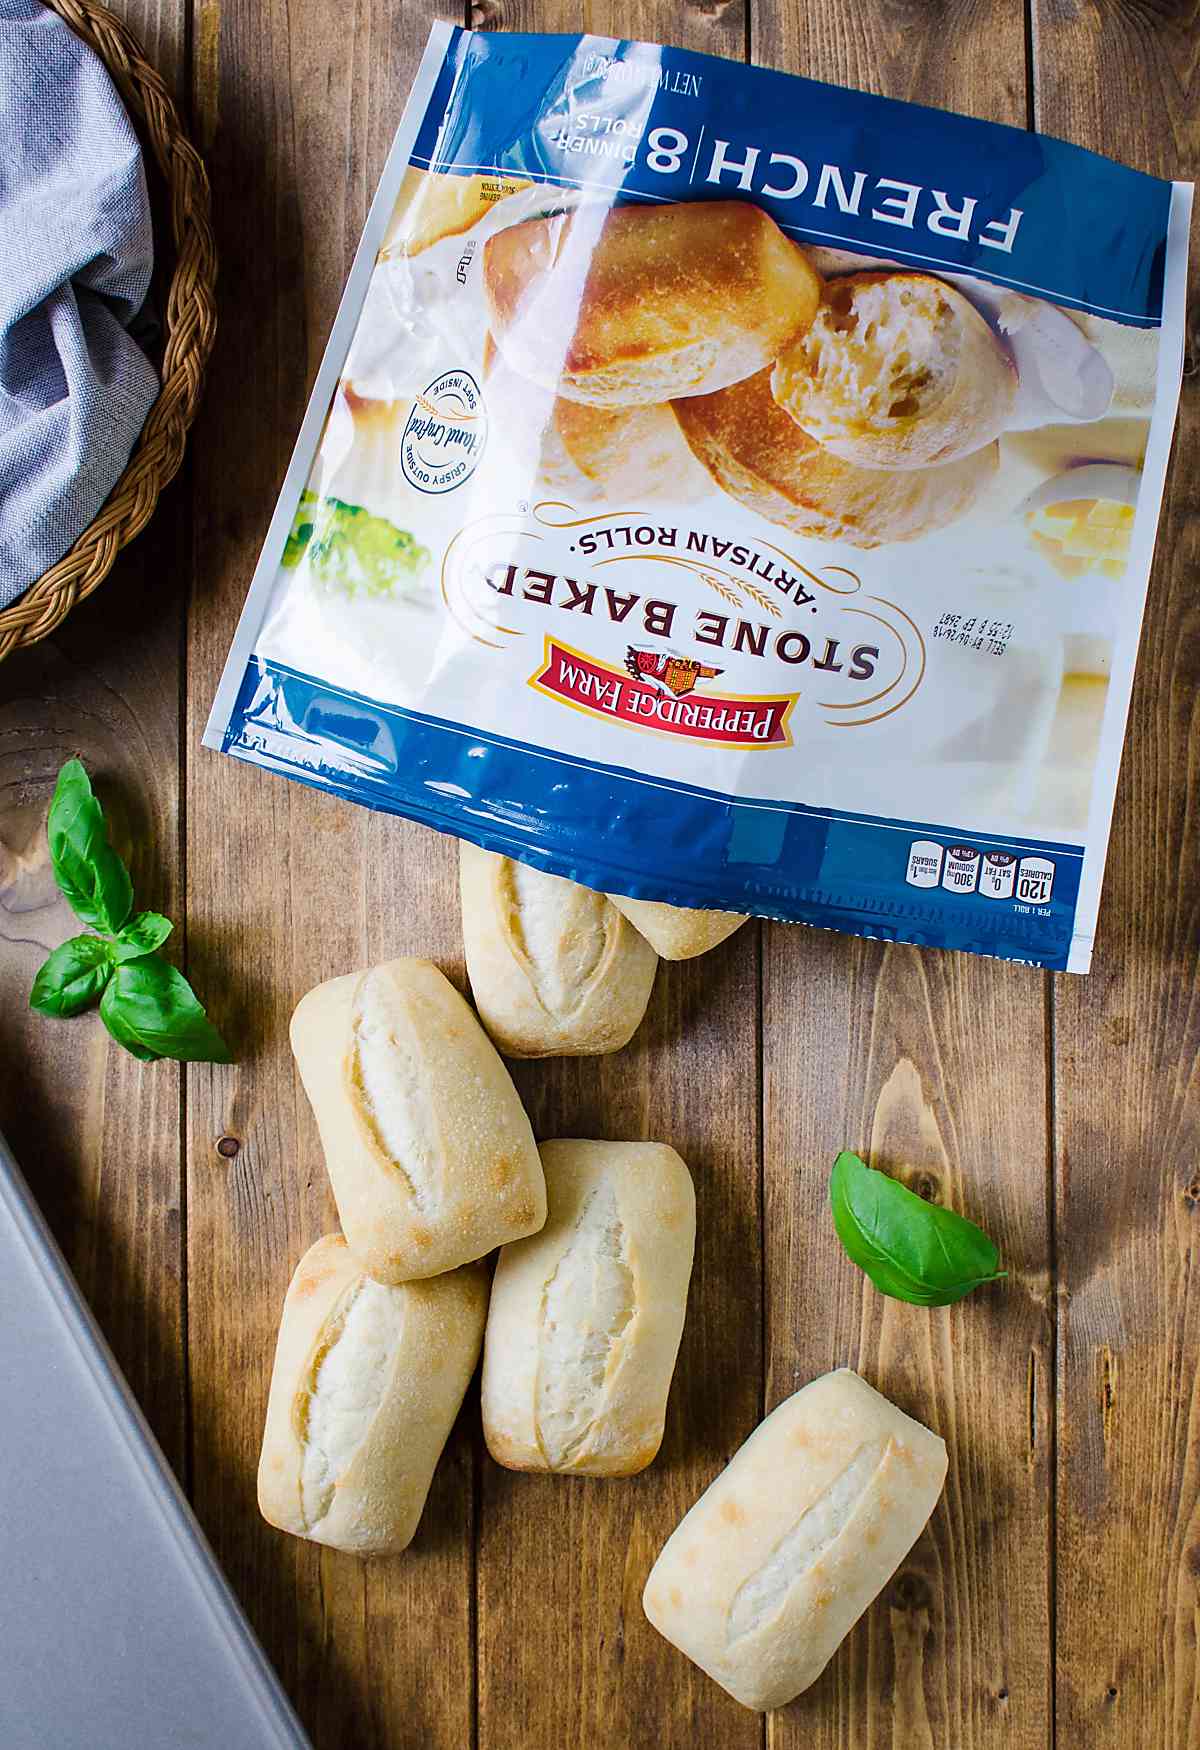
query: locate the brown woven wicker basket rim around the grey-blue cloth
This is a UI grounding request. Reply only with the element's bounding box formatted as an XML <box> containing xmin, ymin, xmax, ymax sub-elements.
<box><xmin>0</xmin><ymin>0</ymin><xmax>217</xmax><ymax>662</ymax></box>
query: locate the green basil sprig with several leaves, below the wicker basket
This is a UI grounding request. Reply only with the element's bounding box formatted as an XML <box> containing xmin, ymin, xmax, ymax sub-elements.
<box><xmin>30</xmin><ymin>760</ymin><xmax>229</xmax><ymax>1064</ymax></box>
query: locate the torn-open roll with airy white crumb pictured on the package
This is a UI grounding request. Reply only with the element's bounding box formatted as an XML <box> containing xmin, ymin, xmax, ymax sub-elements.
<box><xmin>771</xmin><ymin>273</ymin><xmax>1016</xmax><ymax>467</ymax></box>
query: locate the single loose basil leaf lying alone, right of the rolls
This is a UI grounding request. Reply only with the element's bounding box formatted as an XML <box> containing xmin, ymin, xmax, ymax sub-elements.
<box><xmin>829</xmin><ymin>1152</ymin><xmax>1008</xmax><ymax>1307</ymax></box>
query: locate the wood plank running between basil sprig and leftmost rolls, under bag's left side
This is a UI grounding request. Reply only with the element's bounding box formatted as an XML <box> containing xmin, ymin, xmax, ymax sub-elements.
<box><xmin>187</xmin><ymin>0</ymin><xmax>474</xmax><ymax>1750</ymax></box>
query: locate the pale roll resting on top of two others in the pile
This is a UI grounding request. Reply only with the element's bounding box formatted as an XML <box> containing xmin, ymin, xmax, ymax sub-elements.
<box><xmin>292</xmin><ymin>961</ymin><xmax>546</xmax><ymax>1283</ymax></box>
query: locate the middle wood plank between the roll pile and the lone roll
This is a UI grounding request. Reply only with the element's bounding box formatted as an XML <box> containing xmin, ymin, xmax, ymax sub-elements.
<box><xmin>476</xmin><ymin>0</ymin><xmax>763</xmax><ymax>1750</ymax></box>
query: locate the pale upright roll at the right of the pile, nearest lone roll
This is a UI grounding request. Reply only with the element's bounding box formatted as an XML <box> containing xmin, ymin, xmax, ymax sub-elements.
<box><xmin>481</xmin><ymin>1141</ymin><xmax>696</xmax><ymax>1477</ymax></box>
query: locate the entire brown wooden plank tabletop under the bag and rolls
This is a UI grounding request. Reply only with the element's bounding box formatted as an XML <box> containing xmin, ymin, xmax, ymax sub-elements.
<box><xmin>0</xmin><ymin>0</ymin><xmax>1200</xmax><ymax>1750</ymax></box>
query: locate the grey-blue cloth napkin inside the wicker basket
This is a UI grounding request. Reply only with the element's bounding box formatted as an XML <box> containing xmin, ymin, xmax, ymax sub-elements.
<box><xmin>0</xmin><ymin>0</ymin><xmax>157</xmax><ymax>607</ymax></box>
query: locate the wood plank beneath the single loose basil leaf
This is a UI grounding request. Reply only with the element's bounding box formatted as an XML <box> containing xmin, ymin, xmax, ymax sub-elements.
<box><xmin>750</xmin><ymin>0</ymin><xmax>1053</xmax><ymax>1750</ymax></box>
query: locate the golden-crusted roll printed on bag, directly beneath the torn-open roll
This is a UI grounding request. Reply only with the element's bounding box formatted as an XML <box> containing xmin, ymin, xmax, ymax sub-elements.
<box><xmin>675</xmin><ymin>371</ymin><xmax>999</xmax><ymax>548</ymax></box>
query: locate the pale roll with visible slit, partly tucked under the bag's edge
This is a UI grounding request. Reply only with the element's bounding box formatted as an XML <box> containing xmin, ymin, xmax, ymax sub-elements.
<box><xmin>458</xmin><ymin>838</ymin><xmax>658</xmax><ymax>1057</ymax></box>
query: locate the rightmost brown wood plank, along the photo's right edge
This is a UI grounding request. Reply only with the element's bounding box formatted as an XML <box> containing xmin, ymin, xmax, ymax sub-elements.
<box><xmin>1034</xmin><ymin>0</ymin><xmax>1200</xmax><ymax>1750</ymax></box>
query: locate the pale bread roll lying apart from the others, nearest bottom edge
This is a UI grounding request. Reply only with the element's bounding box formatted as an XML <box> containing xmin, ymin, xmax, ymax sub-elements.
<box><xmin>642</xmin><ymin>1369</ymin><xmax>946</xmax><ymax>1710</ymax></box>
